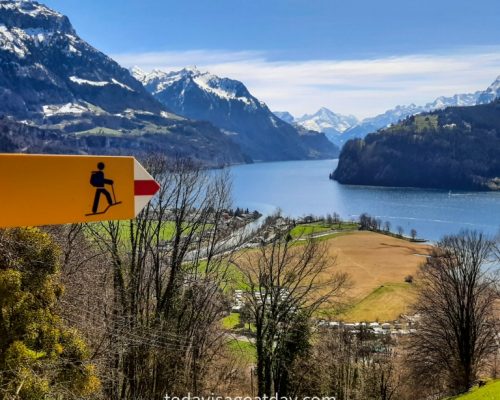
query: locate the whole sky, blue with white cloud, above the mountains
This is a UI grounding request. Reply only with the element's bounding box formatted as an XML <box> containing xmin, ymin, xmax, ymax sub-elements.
<box><xmin>45</xmin><ymin>0</ymin><xmax>500</xmax><ymax>116</ymax></box>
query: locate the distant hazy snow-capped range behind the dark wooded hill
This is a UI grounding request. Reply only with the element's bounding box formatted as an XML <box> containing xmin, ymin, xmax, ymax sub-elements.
<box><xmin>276</xmin><ymin>76</ymin><xmax>500</xmax><ymax>147</ymax></box>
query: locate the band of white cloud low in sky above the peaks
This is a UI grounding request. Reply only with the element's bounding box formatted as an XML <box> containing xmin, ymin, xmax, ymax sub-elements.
<box><xmin>114</xmin><ymin>48</ymin><xmax>500</xmax><ymax>117</ymax></box>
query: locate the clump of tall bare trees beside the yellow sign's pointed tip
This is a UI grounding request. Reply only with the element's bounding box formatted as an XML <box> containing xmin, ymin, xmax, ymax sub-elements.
<box><xmin>83</xmin><ymin>157</ymin><xmax>239</xmax><ymax>399</ymax></box>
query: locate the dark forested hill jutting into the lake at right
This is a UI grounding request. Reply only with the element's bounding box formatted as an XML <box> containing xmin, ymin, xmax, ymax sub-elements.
<box><xmin>331</xmin><ymin>100</ymin><xmax>500</xmax><ymax>190</ymax></box>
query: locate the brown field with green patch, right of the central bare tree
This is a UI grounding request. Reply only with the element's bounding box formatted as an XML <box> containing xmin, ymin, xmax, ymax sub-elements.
<box><xmin>320</xmin><ymin>232</ymin><xmax>430</xmax><ymax>321</ymax></box>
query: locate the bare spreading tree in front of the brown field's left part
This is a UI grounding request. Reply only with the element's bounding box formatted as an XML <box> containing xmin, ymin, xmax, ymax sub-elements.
<box><xmin>237</xmin><ymin>229</ymin><xmax>346</xmax><ymax>396</ymax></box>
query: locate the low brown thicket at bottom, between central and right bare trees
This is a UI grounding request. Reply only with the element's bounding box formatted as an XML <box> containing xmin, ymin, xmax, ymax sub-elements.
<box><xmin>292</xmin><ymin>326</ymin><xmax>401</xmax><ymax>400</ymax></box>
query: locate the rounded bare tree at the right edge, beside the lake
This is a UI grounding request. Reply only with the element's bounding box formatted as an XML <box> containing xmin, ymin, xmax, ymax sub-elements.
<box><xmin>409</xmin><ymin>231</ymin><xmax>499</xmax><ymax>394</ymax></box>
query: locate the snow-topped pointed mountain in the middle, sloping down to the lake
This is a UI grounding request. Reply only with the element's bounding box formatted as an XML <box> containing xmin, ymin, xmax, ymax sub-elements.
<box><xmin>131</xmin><ymin>67</ymin><xmax>338</xmax><ymax>161</ymax></box>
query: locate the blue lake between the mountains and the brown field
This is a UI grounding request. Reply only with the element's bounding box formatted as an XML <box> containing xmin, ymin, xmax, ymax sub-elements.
<box><xmin>230</xmin><ymin>160</ymin><xmax>500</xmax><ymax>241</ymax></box>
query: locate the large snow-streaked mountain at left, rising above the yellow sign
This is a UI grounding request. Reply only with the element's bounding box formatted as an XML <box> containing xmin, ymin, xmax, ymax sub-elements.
<box><xmin>0</xmin><ymin>0</ymin><xmax>244</xmax><ymax>164</ymax></box>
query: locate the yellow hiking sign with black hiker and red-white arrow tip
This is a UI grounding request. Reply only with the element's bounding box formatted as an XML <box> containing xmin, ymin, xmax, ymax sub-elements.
<box><xmin>0</xmin><ymin>154</ymin><xmax>160</xmax><ymax>228</ymax></box>
